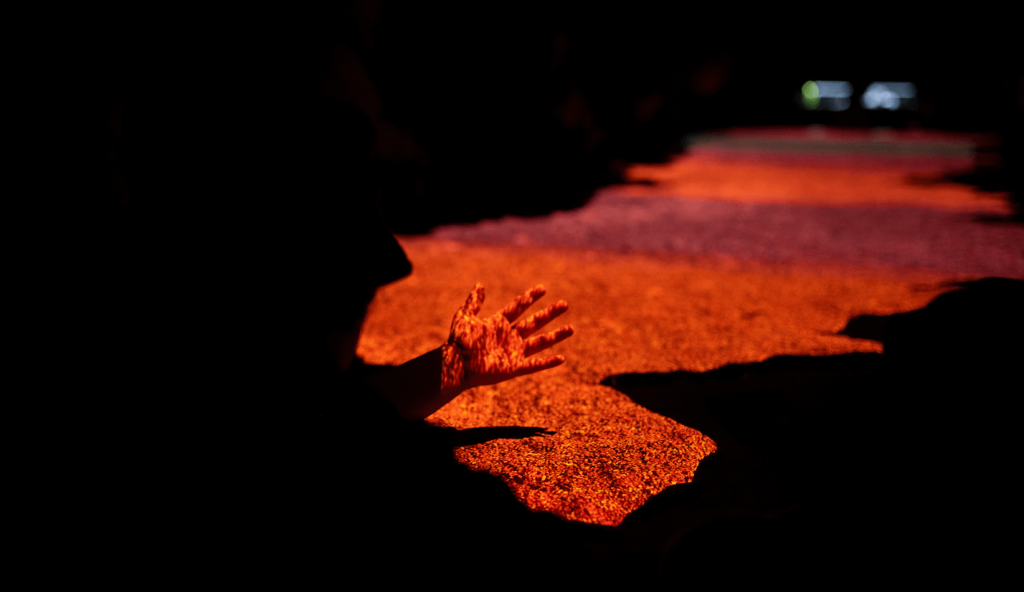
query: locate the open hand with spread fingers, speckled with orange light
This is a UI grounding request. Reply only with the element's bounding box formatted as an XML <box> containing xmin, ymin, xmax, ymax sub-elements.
<box><xmin>441</xmin><ymin>284</ymin><xmax>573</xmax><ymax>396</ymax></box>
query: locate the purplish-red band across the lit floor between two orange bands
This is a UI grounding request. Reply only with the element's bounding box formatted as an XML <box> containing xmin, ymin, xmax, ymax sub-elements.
<box><xmin>432</xmin><ymin>194</ymin><xmax>1024</xmax><ymax>277</ymax></box>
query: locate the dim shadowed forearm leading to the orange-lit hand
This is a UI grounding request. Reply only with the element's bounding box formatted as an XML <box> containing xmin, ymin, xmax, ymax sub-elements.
<box><xmin>367</xmin><ymin>345</ymin><xmax>462</xmax><ymax>420</ymax></box>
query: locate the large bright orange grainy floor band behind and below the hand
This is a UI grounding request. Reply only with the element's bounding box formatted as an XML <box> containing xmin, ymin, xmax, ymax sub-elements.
<box><xmin>358</xmin><ymin>239</ymin><xmax>948</xmax><ymax>525</ymax></box>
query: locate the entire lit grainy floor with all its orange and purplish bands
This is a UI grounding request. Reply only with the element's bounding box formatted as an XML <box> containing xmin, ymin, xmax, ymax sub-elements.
<box><xmin>358</xmin><ymin>128</ymin><xmax>1024</xmax><ymax>525</ymax></box>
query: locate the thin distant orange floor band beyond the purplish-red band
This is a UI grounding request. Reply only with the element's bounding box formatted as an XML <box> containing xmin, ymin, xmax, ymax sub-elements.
<box><xmin>602</xmin><ymin>156</ymin><xmax>1013</xmax><ymax>214</ymax></box>
